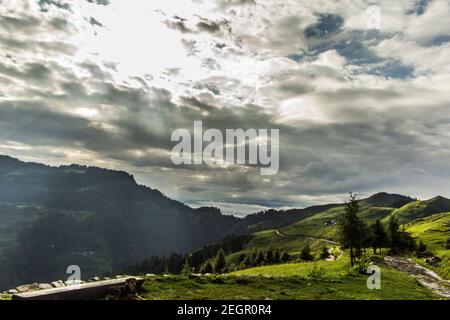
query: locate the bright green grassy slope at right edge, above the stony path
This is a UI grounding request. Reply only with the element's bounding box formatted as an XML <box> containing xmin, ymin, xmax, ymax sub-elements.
<box><xmin>406</xmin><ymin>212</ymin><xmax>450</xmax><ymax>279</ymax></box>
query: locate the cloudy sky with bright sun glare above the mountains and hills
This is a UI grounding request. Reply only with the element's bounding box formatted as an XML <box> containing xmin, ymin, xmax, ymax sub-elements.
<box><xmin>0</xmin><ymin>0</ymin><xmax>450</xmax><ymax>216</ymax></box>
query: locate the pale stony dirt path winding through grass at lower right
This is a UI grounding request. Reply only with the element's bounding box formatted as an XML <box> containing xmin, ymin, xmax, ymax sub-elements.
<box><xmin>384</xmin><ymin>256</ymin><xmax>450</xmax><ymax>298</ymax></box>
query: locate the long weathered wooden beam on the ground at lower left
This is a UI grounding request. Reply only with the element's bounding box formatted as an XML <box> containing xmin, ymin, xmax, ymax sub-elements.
<box><xmin>12</xmin><ymin>277</ymin><xmax>144</xmax><ymax>300</ymax></box>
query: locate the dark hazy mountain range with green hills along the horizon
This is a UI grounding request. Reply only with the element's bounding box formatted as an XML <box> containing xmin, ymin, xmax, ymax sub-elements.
<box><xmin>0</xmin><ymin>156</ymin><xmax>450</xmax><ymax>289</ymax></box>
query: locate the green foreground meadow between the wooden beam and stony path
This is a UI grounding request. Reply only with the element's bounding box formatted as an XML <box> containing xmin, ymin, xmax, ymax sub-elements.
<box><xmin>141</xmin><ymin>258</ymin><xmax>436</xmax><ymax>300</ymax></box>
